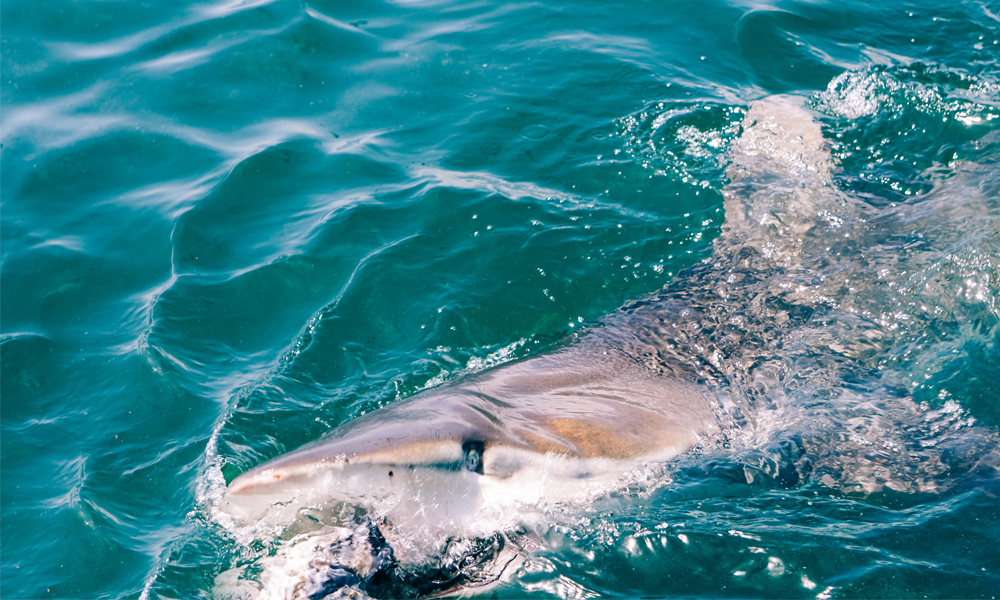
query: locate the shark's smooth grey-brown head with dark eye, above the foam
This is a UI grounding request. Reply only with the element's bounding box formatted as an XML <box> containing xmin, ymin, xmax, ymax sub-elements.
<box><xmin>224</xmin><ymin>355</ymin><xmax>714</xmax><ymax>535</ymax></box>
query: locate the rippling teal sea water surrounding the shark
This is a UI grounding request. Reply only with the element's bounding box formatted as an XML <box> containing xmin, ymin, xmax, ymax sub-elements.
<box><xmin>0</xmin><ymin>0</ymin><xmax>1000</xmax><ymax>598</ymax></box>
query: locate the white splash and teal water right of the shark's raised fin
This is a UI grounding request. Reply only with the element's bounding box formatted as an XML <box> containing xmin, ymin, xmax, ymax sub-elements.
<box><xmin>812</xmin><ymin>63</ymin><xmax>1000</xmax><ymax>202</ymax></box>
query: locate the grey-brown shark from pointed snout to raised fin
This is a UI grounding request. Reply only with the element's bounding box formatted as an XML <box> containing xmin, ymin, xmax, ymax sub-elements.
<box><xmin>220</xmin><ymin>96</ymin><xmax>991</xmax><ymax>598</ymax></box>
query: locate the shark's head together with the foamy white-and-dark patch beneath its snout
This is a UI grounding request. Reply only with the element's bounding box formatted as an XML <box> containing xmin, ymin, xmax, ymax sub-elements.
<box><xmin>222</xmin><ymin>348</ymin><xmax>715</xmax><ymax>596</ymax></box>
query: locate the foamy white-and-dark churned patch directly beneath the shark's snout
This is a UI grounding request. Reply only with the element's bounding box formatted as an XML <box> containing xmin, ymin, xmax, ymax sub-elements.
<box><xmin>215</xmin><ymin>517</ymin><xmax>519</xmax><ymax>600</ymax></box>
